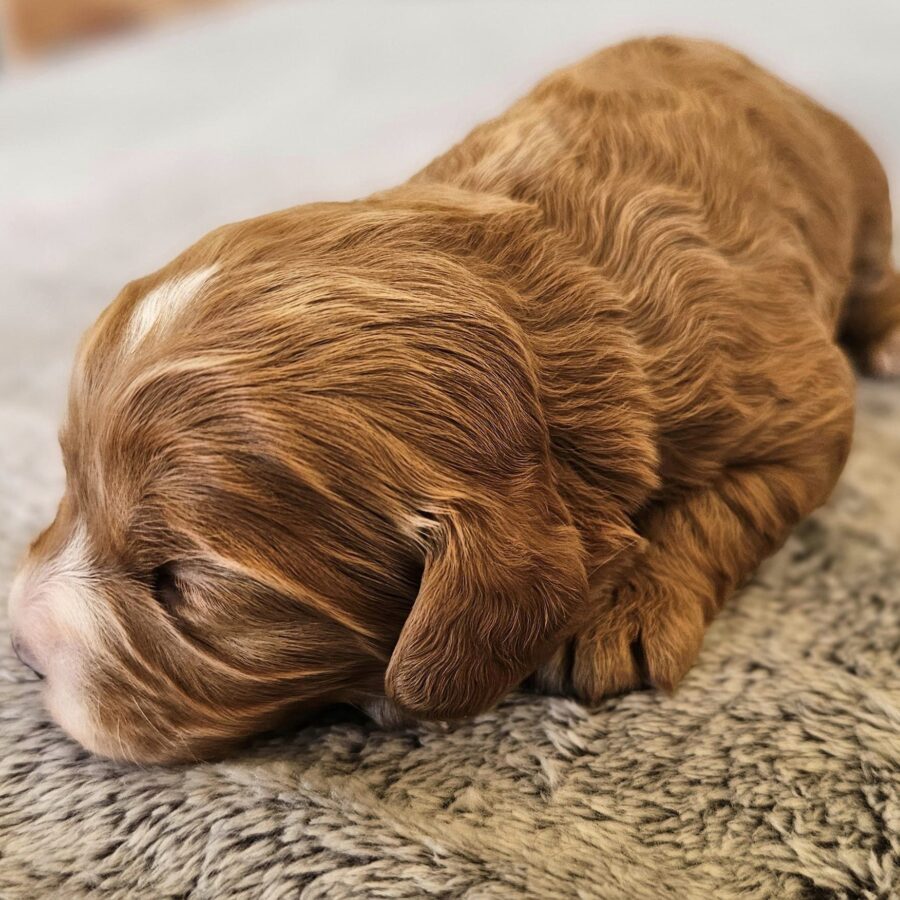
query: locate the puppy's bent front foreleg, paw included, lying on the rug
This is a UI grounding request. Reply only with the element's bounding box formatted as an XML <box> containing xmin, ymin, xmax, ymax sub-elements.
<box><xmin>572</xmin><ymin>465</ymin><xmax>824</xmax><ymax>700</ymax></box>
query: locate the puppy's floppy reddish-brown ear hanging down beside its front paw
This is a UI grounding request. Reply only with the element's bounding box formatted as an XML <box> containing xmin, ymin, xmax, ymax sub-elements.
<box><xmin>385</xmin><ymin>487</ymin><xmax>587</xmax><ymax>719</ymax></box>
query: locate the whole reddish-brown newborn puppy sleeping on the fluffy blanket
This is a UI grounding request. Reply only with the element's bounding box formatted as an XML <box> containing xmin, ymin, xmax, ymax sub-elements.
<box><xmin>10</xmin><ymin>38</ymin><xmax>900</xmax><ymax>761</ymax></box>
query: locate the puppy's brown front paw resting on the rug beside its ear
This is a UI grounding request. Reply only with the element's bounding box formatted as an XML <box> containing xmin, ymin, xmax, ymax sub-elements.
<box><xmin>571</xmin><ymin>588</ymin><xmax>706</xmax><ymax>702</ymax></box>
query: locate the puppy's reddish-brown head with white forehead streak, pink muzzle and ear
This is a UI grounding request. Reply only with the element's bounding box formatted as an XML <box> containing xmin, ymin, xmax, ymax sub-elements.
<box><xmin>10</xmin><ymin>204</ymin><xmax>586</xmax><ymax>761</ymax></box>
